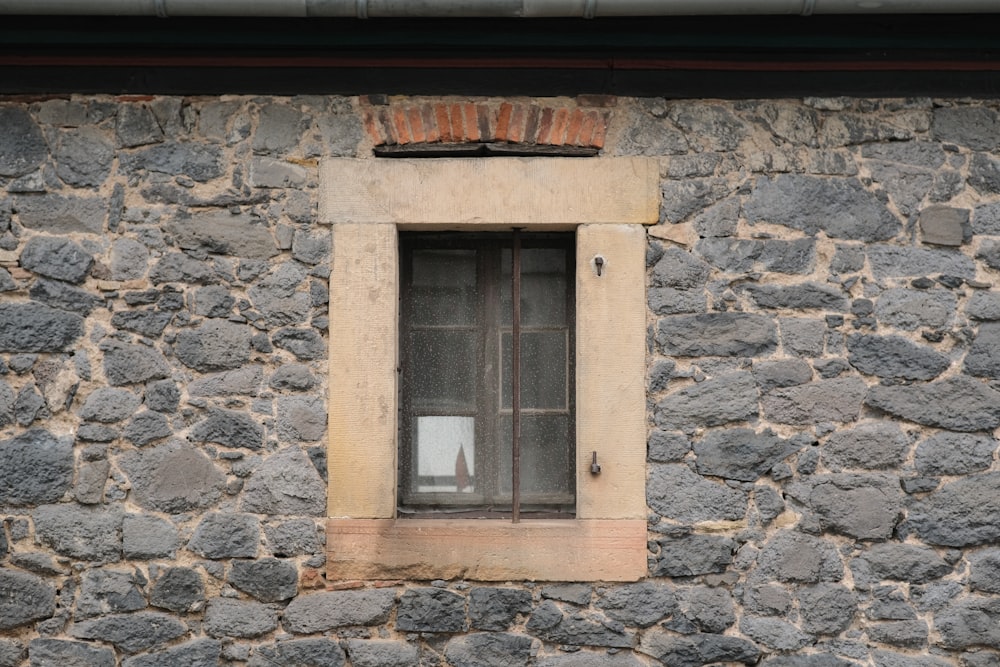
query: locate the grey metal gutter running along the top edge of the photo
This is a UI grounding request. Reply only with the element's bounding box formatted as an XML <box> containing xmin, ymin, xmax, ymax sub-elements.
<box><xmin>0</xmin><ymin>0</ymin><xmax>1000</xmax><ymax>19</ymax></box>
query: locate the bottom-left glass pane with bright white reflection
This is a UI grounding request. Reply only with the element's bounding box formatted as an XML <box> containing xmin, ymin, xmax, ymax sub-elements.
<box><xmin>411</xmin><ymin>417</ymin><xmax>476</xmax><ymax>493</ymax></box>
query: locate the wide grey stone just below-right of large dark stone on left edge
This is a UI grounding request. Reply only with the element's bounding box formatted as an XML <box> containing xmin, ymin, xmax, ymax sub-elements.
<box><xmin>32</xmin><ymin>504</ymin><xmax>124</xmax><ymax>563</ymax></box>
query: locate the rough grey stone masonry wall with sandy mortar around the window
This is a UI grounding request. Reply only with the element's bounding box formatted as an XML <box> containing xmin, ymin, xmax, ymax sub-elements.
<box><xmin>0</xmin><ymin>96</ymin><xmax>1000</xmax><ymax>667</ymax></box>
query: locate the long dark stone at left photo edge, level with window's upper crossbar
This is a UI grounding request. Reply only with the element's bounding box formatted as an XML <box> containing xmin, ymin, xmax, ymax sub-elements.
<box><xmin>0</xmin><ymin>303</ymin><xmax>83</xmax><ymax>352</ymax></box>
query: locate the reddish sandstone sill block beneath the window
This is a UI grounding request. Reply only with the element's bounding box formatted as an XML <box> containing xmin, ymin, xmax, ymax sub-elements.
<box><xmin>326</xmin><ymin>519</ymin><xmax>647</xmax><ymax>581</ymax></box>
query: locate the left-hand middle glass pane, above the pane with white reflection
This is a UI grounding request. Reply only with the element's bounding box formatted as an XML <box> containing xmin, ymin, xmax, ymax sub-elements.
<box><xmin>407</xmin><ymin>329</ymin><xmax>478</xmax><ymax>412</ymax></box>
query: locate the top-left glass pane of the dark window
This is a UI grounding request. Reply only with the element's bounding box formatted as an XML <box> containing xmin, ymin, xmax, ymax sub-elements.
<box><xmin>410</xmin><ymin>250</ymin><xmax>476</xmax><ymax>326</ymax></box>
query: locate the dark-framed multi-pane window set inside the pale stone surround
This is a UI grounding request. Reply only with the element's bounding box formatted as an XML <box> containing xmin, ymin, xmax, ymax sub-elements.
<box><xmin>399</xmin><ymin>232</ymin><xmax>575</xmax><ymax>520</ymax></box>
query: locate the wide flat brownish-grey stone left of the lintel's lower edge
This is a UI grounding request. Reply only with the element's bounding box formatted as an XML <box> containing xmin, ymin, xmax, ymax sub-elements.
<box><xmin>166</xmin><ymin>212</ymin><xmax>278</xmax><ymax>259</ymax></box>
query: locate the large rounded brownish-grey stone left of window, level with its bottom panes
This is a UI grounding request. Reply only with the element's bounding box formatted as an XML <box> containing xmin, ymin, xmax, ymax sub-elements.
<box><xmin>120</xmin><ymin>440</ymin><xmax>226</xmax><ymax>513</ymax></box>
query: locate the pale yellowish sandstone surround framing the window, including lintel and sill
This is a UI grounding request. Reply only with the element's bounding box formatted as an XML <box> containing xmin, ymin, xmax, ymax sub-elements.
<box><xmin>320</xmin><ymin>158</ymin><xmax>660</xmax><ymax>581</ymax></box>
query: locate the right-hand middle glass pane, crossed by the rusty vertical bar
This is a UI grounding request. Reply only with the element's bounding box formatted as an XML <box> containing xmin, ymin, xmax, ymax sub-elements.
<box><xmin>501</xmin><ymin>331</ymin><xmax>568</xmax><ymax>410</ymax></box>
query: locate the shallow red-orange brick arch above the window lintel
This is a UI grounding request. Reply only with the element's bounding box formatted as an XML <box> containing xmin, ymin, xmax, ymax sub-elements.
<box><xmin>362</xmin><ymin>98</ymin><xmax>611</xmax><ymax>149</ymax></box>
